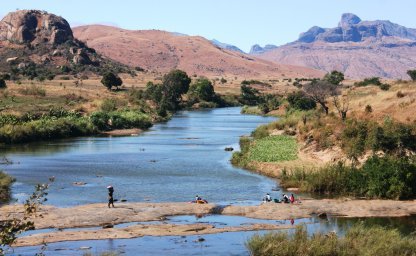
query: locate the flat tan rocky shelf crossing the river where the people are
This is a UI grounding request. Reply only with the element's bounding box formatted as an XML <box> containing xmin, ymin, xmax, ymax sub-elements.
<box><xmin>0</xmin><ymin>199</ymin><xmax>416</xmax><ymax>246</ymax></box>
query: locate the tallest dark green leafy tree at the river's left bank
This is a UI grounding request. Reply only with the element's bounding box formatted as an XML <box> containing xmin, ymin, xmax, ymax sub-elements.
<box><xmin>162</xmin><ymin>69</ymin><xmax>191</xmax><ymax>110</ymax></box>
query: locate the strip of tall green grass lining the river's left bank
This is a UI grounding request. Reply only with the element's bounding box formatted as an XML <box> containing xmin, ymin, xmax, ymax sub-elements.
<box><xmin>0</xmin><ymin>110</ymin><xmax>152</xmax><ymax>144</ymax></box>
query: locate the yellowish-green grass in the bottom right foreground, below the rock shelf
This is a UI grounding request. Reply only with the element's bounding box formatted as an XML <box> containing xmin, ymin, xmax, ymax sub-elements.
<box><xmin>246</xmin><ymin>224</ymin><xmax>416</xmax><ymax>256</ymax></box>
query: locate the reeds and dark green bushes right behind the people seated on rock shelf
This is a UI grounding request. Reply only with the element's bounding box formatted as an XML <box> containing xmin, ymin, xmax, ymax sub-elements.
<box><xmin>281</xmin><ymin>156</ymin><xmax>416</xmax><ymax>199</ymax></box>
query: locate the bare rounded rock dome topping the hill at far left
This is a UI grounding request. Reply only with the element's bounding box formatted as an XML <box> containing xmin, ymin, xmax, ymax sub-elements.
<box><xmin>0</xmin><ymin>10</ymin><xmax>74</xmax><ymax>45</ymax></box>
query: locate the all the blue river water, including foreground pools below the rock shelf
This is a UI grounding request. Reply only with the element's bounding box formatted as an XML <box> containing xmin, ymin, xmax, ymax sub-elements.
<box><xmin>1</xmin><ymin>108</ymin><xmax>416</xmax><ymax>256</ymax></box>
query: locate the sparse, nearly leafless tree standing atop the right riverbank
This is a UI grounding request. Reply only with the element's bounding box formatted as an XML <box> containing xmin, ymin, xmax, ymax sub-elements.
<box><xmin>303</xmin><ymin>80</ymin><xmax>339</xmax><ymax>115</ymax></box>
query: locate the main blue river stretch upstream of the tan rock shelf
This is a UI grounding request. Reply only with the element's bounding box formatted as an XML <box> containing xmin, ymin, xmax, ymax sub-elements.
<box><xmin>1</xmin><ymin>108</ymin><xmax>278</xmax><ymax>207</ymax></box>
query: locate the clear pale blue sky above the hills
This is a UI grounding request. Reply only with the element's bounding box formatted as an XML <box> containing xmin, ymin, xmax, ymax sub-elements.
<box><xmin>0</xmin><ymin>0</ymin><xmax>416</xmax><ymax>51</ymax></box>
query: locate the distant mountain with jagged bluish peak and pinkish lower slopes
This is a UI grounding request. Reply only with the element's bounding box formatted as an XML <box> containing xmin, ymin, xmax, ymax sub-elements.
<box><xmin>251</xmin><ymin>13</ymin><xmax>416</xmax><ymax>79</ymax></box>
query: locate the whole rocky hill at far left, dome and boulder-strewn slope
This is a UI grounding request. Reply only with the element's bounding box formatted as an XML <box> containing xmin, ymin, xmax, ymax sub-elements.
<box><xmin>0</xmin><ymin>10</ymin><xmax>129</xmax><ymax>78</ymax></box>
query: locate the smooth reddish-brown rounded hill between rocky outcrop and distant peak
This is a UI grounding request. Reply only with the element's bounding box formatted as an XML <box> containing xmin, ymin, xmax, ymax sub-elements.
<box><xmin>73</xmin><ymin>25</ymin><xmax>322</xmax><ymax>78</ymax></box>
